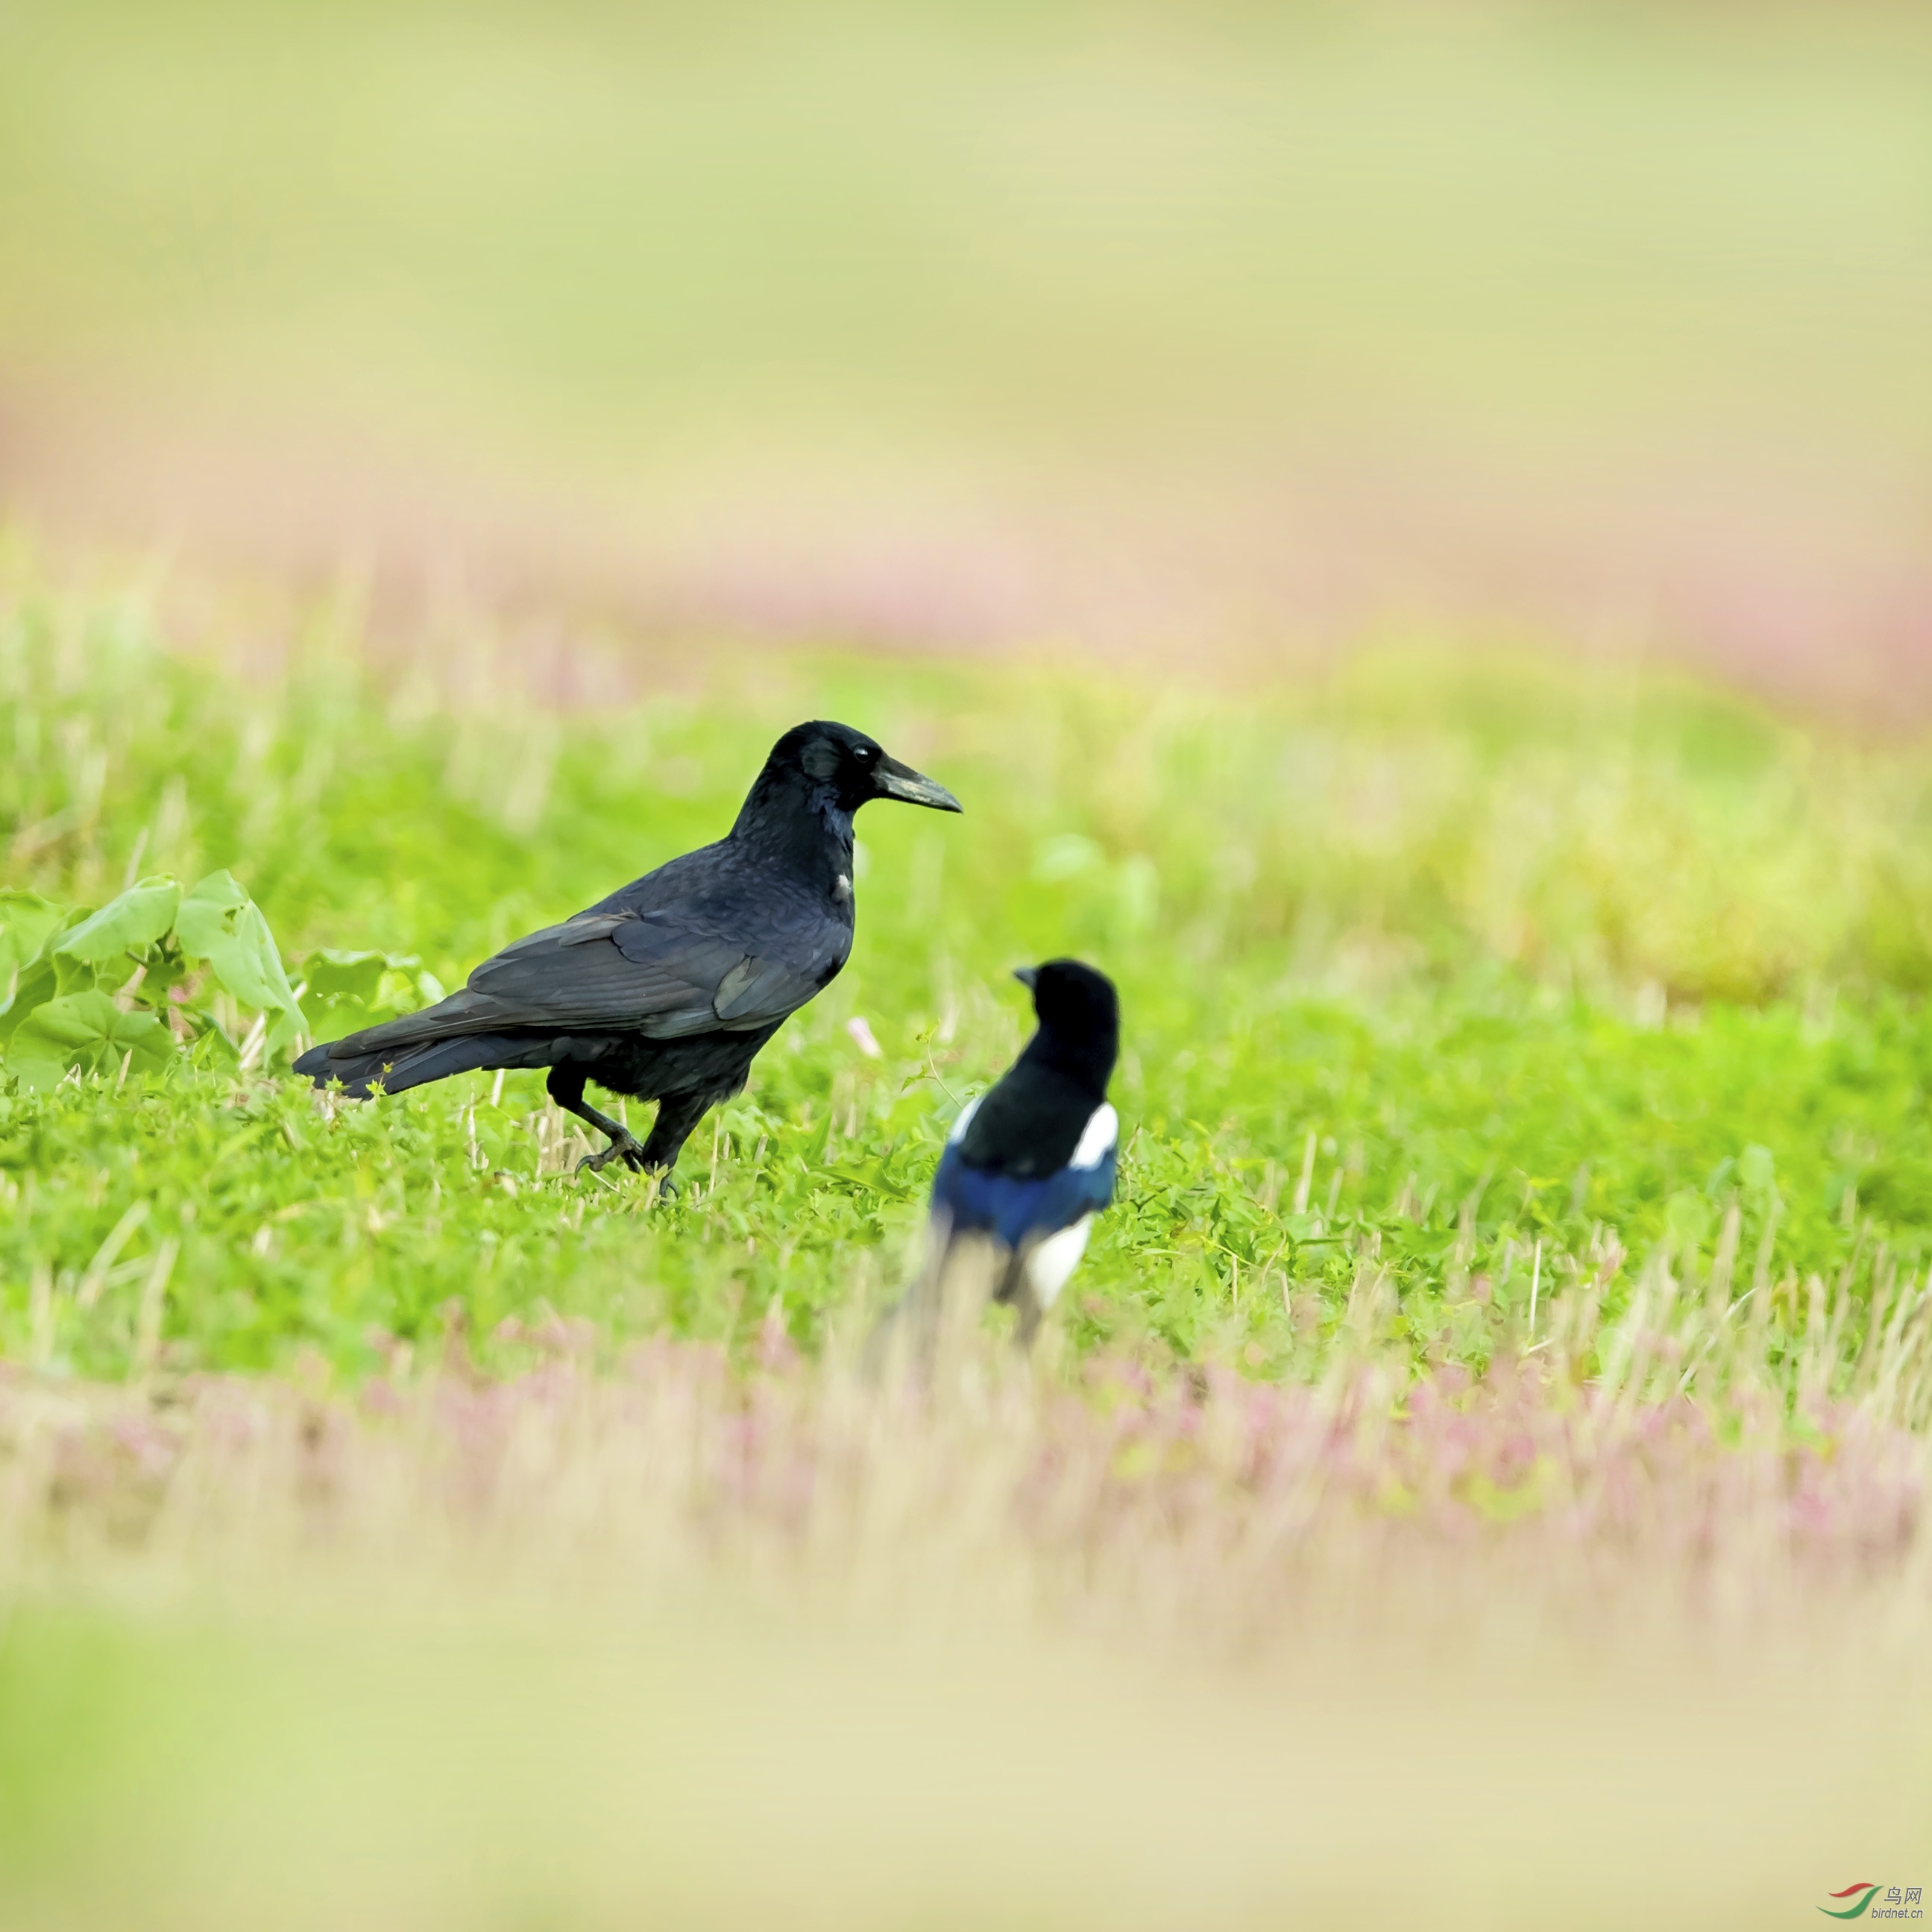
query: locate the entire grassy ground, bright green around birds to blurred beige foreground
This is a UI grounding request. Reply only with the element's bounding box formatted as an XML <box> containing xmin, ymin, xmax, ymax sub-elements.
<box><xmin>0</xmin><ymin>539</ymin><xmax>1932</xmax><ymax>1928</ymax></box>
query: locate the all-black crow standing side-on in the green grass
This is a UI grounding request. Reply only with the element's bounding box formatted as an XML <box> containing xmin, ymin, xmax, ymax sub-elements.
<box><xmin>295</xmin><ymin>720</ymin><xmax>962</xmax><ymax>1184</ymax></box>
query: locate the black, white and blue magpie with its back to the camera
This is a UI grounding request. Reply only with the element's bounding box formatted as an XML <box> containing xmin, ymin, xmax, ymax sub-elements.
<box><xmin>928</xmin><ymin>960</ymin><xmax>1121</xmax><ymax>1347</ymax></box>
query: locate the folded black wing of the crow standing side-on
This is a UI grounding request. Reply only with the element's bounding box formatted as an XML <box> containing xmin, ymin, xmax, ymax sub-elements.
<box><xmin>324</xmin><ymin>912</ymin><xmax>852</xmax><ymax>1051</ymax></box>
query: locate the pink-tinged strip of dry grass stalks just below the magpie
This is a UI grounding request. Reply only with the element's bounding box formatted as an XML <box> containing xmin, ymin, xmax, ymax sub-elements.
<box><xmin>0</xmin><ymin>1298</ymin><xmax>1932</xmax><ymax>1654</ymax></box>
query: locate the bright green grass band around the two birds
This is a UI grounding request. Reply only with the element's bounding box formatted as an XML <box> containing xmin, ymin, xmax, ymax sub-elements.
<box><xmin>0</xmin><ymin>545</ymin><xmax>1932</xmax><ymax>1398</ymax></box>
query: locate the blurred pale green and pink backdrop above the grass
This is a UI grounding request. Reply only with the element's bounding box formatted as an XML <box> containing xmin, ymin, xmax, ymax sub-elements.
<box><xmin>0</xmin><ymin>0</ymin><xmax>1932</xmax><ymax>693</ymax></box>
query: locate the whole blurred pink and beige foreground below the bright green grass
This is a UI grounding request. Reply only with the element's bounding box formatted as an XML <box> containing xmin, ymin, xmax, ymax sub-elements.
<box><xmin>0</xmin><ymin>1324</ymin><xmax>1932</xmax><ymax>1932</ymax></box>
